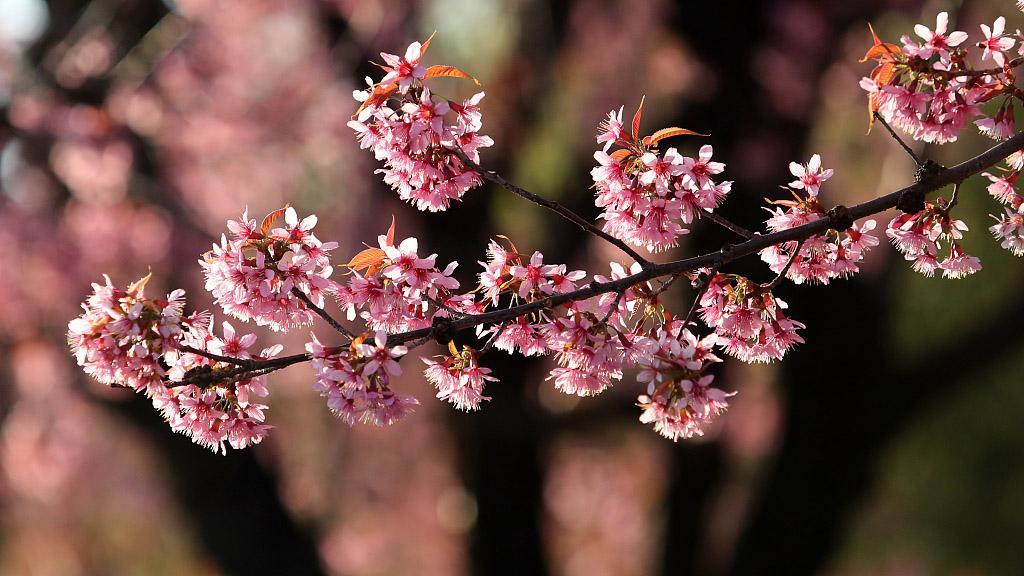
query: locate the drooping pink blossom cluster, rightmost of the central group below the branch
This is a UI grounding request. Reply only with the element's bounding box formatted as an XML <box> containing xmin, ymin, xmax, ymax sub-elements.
<box><xmin>699</xmin><ymin>274</ymin><xmax>805</xmax><ymax>362</ymax></box>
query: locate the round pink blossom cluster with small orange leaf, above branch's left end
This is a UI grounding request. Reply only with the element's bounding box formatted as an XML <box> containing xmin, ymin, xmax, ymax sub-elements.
<box><xmin>200</xmin><ymin>206</ymin><xmax>338</xmax><ymax>332</ymax></box>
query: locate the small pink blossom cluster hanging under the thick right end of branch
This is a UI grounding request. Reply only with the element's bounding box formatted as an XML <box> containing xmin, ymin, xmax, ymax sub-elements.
<box><xmin>886</xmin><ymin>198</ymin><xmax>981</xmax><ymax>278</ymax></box>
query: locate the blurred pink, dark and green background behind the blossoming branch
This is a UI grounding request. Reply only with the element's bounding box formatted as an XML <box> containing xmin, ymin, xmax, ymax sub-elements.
<box><xmin>0</xmin><ymin>0</ymin><xmax>1024</xmax><ymax>576</ymax></box>
